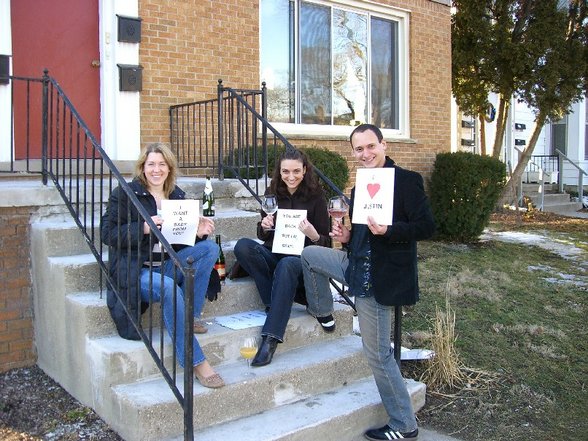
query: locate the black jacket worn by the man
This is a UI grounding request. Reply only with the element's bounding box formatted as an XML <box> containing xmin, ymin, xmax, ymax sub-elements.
<box><xmin>346</xmin><ymin>157</ymin><xmax>435</xmax><ymax>306</ymax></box>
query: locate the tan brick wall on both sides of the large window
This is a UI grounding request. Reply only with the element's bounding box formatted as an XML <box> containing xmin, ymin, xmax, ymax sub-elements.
<box><xmin>139</xmin><ymin>0</ymin><xmax>451</xmax><ymax>187</ymax></box>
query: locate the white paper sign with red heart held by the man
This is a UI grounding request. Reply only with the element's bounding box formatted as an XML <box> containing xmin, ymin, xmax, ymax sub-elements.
<box><xmin>351</xmin><ymin>168</ymin><xmax>395</xmax><ymax>225</ymax></box>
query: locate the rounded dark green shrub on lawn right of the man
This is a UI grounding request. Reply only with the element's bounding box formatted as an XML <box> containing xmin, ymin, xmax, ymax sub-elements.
<box><xmin>430</xmin><ymin>152</ymin><xmax>506</xmax><ymax>243</ymax></box>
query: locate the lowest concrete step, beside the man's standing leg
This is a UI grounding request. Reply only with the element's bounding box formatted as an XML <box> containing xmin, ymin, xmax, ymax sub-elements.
<box><xmin>170</xmin><ymin>376</ymin><xmax>426</xmax><ymax>441</ymax></box>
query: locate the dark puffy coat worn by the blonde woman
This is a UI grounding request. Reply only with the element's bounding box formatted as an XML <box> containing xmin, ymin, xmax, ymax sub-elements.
<box><xmin>100</xmin><ymin>180</ymin><xmax>185</xmax><ymax>340</ymax></box>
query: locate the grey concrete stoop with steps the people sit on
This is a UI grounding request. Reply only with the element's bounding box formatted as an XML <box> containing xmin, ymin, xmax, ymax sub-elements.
<box><xmin>31</xmin><ymin>200</ymin><xmax>426</xmax><ymax>441</ymax></box>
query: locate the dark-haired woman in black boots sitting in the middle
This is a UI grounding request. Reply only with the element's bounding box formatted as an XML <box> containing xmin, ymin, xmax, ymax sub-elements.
<box><xmin>235</xmin><ymin>150</ymin><xmax>334</xmax><ymax>366</ymax></box>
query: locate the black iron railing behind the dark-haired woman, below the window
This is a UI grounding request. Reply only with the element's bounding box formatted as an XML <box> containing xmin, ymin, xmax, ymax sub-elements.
<box><xmin>169</xmin><ymin>80</ymin><xmax>345</xmax><ymax>205</ymax></box>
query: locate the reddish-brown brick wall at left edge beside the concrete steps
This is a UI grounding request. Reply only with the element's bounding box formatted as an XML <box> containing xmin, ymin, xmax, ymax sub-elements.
<box><xmin>0</xmin><ymin>207</ymin><xmax>36</xmax><ymax>372</ymax></box>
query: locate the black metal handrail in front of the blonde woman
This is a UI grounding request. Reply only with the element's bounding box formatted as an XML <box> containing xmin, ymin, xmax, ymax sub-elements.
<box><xmin>4</xmin><ymin>70</ymin><xmax>194</xmax><ymax>440</ymax></box>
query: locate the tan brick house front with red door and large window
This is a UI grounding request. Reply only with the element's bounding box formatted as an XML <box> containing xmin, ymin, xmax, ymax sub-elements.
<box><xmin>0</xmin><ymin>0</ymin><xmax>451</xmax><ymax>180</ymax></box>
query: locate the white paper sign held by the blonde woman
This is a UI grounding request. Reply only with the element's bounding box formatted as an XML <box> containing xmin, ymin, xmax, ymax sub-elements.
<box><xmin>161</xmin><ymin>199</ymin><xmax>200</xmax><ymax>245</ymax></box>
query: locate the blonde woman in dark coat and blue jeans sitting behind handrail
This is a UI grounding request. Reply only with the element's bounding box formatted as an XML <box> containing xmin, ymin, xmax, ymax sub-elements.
<box><xmin>100</xmin><ymin>143</ymin><xmax>224</xmax><ymax>388</ymax></box>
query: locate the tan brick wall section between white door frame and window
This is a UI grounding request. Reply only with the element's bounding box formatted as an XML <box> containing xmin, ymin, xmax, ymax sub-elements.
<box><xmin>139</xmin><ymin>0</ymin><xmax>260</xmax><ymax>144</ymax></box>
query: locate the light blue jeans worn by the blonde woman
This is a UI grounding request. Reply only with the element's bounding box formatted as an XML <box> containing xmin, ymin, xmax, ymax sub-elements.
<box><xmin>141</xmin><ymin>240</ymin><xmax>219</xmax><ymax>367</ymax></box>
